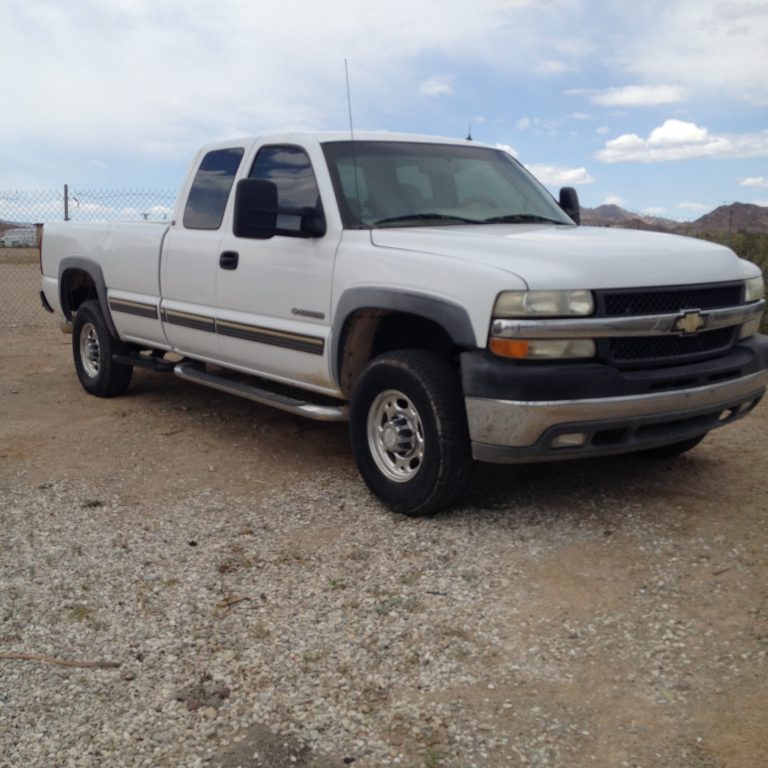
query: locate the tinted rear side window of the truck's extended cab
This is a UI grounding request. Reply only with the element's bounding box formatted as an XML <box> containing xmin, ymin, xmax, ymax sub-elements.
<box><xmin>184</xmin><ymin>148</ymin><xmax>243</xmax><ymax>229</ymax></box>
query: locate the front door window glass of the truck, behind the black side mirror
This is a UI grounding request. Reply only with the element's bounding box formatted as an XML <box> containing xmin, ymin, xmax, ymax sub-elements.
<box><xmin>249</xmin><ymin>146</ymin><xmax>322</xmax><ymax>232</ymax></box>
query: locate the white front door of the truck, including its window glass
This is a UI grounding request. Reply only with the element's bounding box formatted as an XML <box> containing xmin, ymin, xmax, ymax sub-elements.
<box><xmin>216</xmin><ymin>145</ymin><xmax>340</xmax><ymax>392</ymax></box>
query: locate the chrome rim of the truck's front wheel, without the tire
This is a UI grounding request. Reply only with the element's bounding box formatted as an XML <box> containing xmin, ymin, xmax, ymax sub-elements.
<box><xmin>368</xmin><ymin>389</ymin><xmax>424</xmax><ymax>483</ymax></box>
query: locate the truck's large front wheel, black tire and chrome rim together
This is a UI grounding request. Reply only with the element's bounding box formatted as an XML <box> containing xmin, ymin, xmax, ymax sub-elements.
<box><xmin>349</xmin><ymin>350</ymin><xmax>472</xmax><ymax>516</ymax></box>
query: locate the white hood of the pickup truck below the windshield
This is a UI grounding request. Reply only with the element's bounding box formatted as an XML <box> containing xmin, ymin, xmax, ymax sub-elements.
<box><xmin>371</xmin><ymin>224</ymin><xmax>754</xmax><ymax>290</ymax></box>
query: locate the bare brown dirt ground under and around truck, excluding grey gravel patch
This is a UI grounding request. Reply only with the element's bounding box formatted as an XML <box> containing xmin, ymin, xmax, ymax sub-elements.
<box><xmin>0</xmin><ymin>322</ymin><xmax>768</xmax><ymax>768</ymax></box>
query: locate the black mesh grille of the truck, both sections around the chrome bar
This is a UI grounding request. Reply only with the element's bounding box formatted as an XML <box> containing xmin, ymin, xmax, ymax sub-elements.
<box><xmin>595</xmin><ymin>282</ymin><xmax>744</xmax><ymax>368</ymax></box>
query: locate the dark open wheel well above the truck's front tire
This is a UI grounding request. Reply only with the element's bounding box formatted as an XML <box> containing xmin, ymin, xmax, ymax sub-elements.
<box><xmin>337</xmin><ymin>308</ymin><xmax>461</xmax><ymax>395</ymax></box>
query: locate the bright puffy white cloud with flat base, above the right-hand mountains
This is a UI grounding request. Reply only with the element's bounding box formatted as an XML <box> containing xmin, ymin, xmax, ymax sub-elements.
<box><xmin>595</xmin><ymin>120</ymin><xmax>768</xmax><ymax>163</ymax></box>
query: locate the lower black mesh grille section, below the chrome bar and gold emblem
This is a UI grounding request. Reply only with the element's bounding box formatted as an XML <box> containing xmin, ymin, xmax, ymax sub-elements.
<box><xmin>608</xmin><ymin>328</ymin><xmax>736</xmax><ymax>363</ymax></box>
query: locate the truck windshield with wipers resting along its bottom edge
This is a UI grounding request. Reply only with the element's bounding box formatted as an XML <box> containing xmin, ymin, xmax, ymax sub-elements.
<box><xmin>323</xmin><ymin>141</ymin><xmax>573</xmax><ymax>229</ymax></box>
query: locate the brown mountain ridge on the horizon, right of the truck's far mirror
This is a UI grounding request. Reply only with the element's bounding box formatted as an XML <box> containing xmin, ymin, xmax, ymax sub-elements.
<box><xmin>581</xmin><ymin>203</ymin><xmax>768</xmax><ymax>235</ymax></box>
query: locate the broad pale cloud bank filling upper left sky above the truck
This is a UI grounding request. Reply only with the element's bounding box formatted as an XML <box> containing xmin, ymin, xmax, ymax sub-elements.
<box><xmin>0</xmin><ymin>0</ymin><xmax>570</xmax><ymax>166</ymax></box>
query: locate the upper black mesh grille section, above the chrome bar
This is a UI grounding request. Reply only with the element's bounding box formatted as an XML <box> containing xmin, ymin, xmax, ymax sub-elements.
<box><xmin>601</xmin><ymin>283</ymin><xmax>744</xmax><ymax>317</ymax></box>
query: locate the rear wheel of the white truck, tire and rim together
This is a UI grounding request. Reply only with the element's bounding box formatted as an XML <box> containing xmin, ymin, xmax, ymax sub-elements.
<box><xmin>72</xmin><ymin>301</ymin><xmax>133</xmax><ymax>397</ymax></box>
